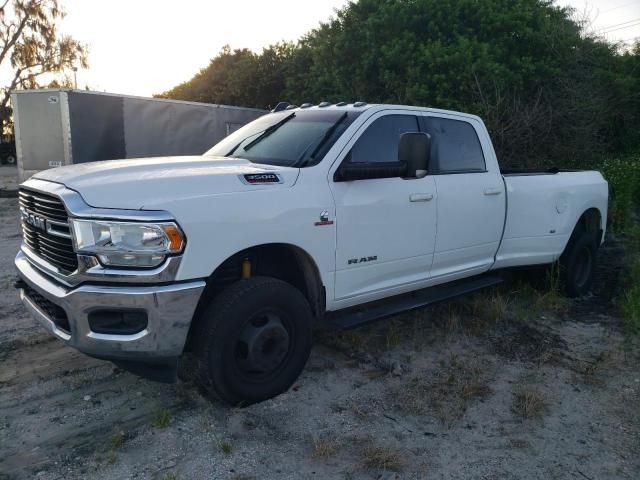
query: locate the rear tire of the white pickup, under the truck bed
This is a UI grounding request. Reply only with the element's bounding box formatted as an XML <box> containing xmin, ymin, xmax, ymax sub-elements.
<box><xmin>560</xmin><ymin>232</ymin><xmax>597</xmax><ymax>298</ymax></box>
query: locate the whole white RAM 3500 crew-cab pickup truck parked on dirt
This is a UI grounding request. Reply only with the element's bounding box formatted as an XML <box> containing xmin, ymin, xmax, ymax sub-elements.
<box><xmin>15</xmin><ymin>102</ymin><xmax>608</xmax><ymax>404</ymax></box>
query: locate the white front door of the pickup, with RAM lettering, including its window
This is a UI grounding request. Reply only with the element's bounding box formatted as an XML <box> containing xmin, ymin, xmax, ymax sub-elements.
<box><xmin>329</xmin><ymin>112</ymin><xmax>436</xmax><ymax>306</ymax></box>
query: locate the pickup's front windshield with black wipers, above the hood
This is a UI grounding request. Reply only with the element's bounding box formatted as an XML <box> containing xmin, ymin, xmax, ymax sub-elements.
<box><xmin>205</xmin><ymin>110</ymin><xmax>360</xmax><ymax>167</ymax></box>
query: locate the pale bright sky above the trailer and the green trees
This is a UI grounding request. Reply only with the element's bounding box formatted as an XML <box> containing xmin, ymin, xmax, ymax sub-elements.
<box><xmin>60</xmin><ymin>0</ymin><xmax>640</xmax><ymax>96</ymax></box>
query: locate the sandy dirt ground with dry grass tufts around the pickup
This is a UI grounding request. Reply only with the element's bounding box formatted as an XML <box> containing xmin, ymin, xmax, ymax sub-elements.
<box><xmin>0</xmin><ymin>198</ymin><xmax>640</xmax><ymax>480</ymax></box>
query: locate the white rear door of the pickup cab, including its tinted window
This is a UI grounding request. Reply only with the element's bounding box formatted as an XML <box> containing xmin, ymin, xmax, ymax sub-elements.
<box><xmin>422</xmin><ymin>114</ymin><xmax>506</xmax><ymax>279</ymax></box>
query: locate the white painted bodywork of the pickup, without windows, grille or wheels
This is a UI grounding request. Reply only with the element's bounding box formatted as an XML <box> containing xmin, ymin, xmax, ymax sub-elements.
<box><xmin>30</xmin><ymin>105</ymin><xmax>607</xmax><ymax>310</ymax></box>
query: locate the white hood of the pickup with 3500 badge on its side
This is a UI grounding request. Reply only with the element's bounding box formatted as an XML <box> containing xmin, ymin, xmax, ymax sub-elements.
<box><xmin>34</xmin><ymin>156</ymin><xmax>300</xmax><ymax>209</ymax></box>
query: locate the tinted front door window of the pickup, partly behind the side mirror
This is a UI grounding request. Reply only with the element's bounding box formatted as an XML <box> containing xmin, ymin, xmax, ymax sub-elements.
<box><xmin>348</xmin><ymin>115</ymin><xmax>420</xmax><ymax>163</ymax></box>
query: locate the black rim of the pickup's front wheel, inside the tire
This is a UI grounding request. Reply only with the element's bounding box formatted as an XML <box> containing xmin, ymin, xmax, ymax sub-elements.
<box><xmin>233</xmin><ymin>309</ymin><xmax>294</xmax><ymax>382</ymax></box>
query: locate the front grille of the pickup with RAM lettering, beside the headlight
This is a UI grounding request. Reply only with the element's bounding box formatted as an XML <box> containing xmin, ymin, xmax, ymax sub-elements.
<box><xmin>19</xmin><ymin>188</ymin><xmax>78</xmax><ymax>274</ymax></box>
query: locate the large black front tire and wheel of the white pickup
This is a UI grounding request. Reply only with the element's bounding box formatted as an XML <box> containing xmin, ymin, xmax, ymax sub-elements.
<box><xmin>195</xmin><ymin>277</ymin><xmax>313</xmax><ymax>405</ymax></box>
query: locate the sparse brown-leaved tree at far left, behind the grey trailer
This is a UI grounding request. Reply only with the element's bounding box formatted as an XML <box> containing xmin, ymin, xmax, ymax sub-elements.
<box><xmin>0</xmin><ymin>0</ymin><xmax>88</xmax><ymax>130</ymax></box>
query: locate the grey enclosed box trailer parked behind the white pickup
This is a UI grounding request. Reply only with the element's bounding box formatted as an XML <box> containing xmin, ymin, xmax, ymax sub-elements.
<box><xmin>11</xmin><ymin>89</ymin><xmax>267</xmax><ymax>181</ymax></box>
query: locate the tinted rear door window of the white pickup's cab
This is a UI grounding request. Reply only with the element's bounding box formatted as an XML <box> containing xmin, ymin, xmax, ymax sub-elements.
<box><xmin>425</xmin><ymin>117</ymin><xmax>486</xmax><ymax>174</ymax></box>
